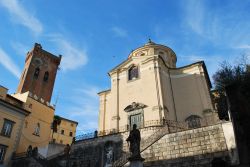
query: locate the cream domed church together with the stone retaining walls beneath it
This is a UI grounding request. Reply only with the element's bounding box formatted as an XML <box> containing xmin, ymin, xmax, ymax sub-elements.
<box><xmin>70</xmin><ymin>40</ymin><xmax>238</xmax><ymax>167</ymax></box>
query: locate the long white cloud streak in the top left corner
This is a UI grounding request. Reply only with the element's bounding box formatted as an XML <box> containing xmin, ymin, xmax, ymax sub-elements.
<box><xmin>0</xmin><ymin>0</ymin><xmax>43</xmax><ymax>34</ymax></box>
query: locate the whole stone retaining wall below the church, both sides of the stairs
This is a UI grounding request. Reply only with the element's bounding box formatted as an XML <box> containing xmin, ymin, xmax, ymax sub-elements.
<box><xmin>71</xmin><ymin>122</ymin><xmax>237</xmax><ymax>167</ymax></box>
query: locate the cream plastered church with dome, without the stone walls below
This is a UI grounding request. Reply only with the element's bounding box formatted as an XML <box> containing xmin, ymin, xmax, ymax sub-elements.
<box><xmin>98</xmin><ymin>41</ymin><xmax>214</xmax><ymax>134</ymax></box>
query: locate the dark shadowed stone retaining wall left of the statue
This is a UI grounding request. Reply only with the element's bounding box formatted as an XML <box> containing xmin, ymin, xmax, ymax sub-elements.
<box><xmin>70</xmin><ymin>134</ymin><xmax>123</xmax><ymax>167</ymax></box>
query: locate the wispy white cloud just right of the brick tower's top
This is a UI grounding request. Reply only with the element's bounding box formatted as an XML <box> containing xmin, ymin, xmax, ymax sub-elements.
<box><xmin>49</xmin><ymin>34</ymin><xmax>88</xmax><ymax>71</ymax></box>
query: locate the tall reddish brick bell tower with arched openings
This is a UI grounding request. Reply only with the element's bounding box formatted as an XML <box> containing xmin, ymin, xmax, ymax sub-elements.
<box><xmin>17</xmin><ymin>43</ymin><xmax>62</xmax><ymax>102</ymax></box>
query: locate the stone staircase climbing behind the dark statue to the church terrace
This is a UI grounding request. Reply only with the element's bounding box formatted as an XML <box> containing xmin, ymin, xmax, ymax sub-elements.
<box><xmin>113</xmin><ymin>120</ymin><xmax>188</xmax><ymax>167</ymax></box>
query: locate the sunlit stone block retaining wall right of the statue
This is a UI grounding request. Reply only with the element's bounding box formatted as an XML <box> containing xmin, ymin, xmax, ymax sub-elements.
<box><xmin>142</xmin><ymin>124</ymin><xmax>228</xmax><ymax>167</ymax></box>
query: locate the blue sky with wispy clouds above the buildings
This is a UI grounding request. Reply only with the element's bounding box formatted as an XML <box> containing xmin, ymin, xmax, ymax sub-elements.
<box><xmin>0</xmin><ymin>0</ymin><xmax>250</xmax><ymax>133</ymax></box>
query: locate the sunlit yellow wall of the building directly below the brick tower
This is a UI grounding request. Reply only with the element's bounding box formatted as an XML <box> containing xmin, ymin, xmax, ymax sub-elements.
<box><xmin>13</xmin><ymin>92</ymin><xmax>54</xmax><ymax>153</ymax></box>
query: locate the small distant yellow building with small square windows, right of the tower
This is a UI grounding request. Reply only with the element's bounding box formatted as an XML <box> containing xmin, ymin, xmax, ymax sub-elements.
<box><xmin>52</xmin><ymin>117</ymin><xmax>78</xmax><ymax>145</ymax></box>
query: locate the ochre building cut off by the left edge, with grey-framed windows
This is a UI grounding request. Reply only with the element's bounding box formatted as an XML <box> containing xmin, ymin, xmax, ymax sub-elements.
<box><xmin>0</xmin><ymin>86</ymin><xmax>30</xmax><ymax>166</ymax></box>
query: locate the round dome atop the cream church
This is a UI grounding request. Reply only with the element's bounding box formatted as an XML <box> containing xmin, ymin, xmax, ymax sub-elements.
<box><xmin>128</xmin><ymin>39</ymin><xmax>177</xmax><ymax>68</ymax></box>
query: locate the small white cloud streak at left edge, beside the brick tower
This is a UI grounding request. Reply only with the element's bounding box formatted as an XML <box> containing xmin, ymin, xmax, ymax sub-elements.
<box><xmin>0</xmin><ymin>48</ymin><xmax>21</xmax><ymax>78</ymax></box>
